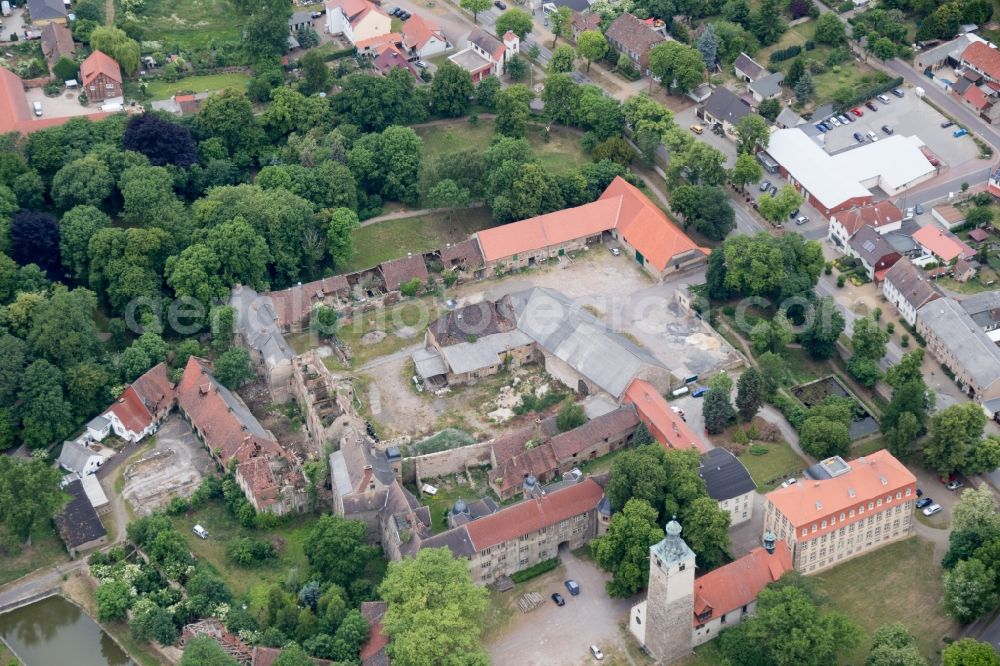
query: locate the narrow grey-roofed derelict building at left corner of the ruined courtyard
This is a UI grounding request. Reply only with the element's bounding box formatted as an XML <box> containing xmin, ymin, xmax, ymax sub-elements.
<box><xmin>229</xmin><ymin>285</ymin><xmax>295</xmax><ymax>402</ymax></box>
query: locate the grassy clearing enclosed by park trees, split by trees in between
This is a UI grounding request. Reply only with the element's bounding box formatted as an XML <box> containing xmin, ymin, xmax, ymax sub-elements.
<box><xmin>416</xmin><ymin>120</ymin><xmax>590</xmax><ymax>173</ymax></box>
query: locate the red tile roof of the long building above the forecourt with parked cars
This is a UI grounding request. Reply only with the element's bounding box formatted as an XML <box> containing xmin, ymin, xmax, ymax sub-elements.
<box><xmin>465</xmin><ymin>479</ymin><xmax>604</xmax><ymax>550</ymax></box>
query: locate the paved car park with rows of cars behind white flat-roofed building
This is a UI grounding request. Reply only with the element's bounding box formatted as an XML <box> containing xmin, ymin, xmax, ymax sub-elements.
<box><xmin>814</xmin><ymin>87</ymin><xmax>979</xmax><ymax>167</ymax></box>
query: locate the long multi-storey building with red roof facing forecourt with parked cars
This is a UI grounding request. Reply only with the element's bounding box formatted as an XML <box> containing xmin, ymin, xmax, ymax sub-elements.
<box><xmin>420</xmin><ymin>478</ymin><xmax>604</xmax><ymax>585</ymax></box>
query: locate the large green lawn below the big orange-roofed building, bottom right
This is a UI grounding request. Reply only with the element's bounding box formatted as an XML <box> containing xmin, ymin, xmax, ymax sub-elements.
<box><xmin>815</xmin><ymin>538</ymin><xmax>958</xmax><ymax>663</ymax></box>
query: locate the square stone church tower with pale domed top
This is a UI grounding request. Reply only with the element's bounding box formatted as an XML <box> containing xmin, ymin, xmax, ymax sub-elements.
<box><xmin>629</xmin><ymin>520</ymin><xmax>694</xmax><ymax>664</ymax></box>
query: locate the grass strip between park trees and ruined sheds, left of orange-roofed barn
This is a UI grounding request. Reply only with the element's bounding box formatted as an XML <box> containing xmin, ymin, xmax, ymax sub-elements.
<box><xmin>342</xmin><ymin>208</ymin><xmax>493</xmax><ymax>273</ymax></box>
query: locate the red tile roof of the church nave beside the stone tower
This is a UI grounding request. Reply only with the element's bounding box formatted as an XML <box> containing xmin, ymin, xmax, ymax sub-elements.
<box><xmin>692</xmin><ymin>541</ymin><xmax>792</xmax><ymax>625</ymax></box>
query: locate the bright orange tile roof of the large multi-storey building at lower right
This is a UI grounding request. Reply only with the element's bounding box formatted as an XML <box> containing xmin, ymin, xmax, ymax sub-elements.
<box><xmin>767</xmin><ymin>449</ymin><xmax>917</xmax><ymax>538</ymax></box>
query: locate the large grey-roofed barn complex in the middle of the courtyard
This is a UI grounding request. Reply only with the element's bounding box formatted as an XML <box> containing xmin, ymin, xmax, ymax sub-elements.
<box><xmin>414</xmin><ymin>287</ymin><xmax>670</xmax><ymax>401</ymax></box>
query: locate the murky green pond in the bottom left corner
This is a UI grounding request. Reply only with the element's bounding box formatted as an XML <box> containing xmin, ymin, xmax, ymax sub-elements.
<box><xmin>0</xmin><ymin>595</ymin><xmax>133</xmax><ymax>666</ymax></box>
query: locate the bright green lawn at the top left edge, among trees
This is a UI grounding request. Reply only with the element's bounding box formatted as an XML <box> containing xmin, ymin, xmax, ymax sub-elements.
<box><xmin>123</xmin><ymin>0</ymin><xmax>243</xmax><ymax>50</ymax></box>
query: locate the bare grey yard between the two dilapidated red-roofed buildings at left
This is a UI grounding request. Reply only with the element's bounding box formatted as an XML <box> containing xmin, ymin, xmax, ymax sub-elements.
<box><xmin>122</xmin><ymin>414</ymin><xmax>215</xmax><ymax>516</ymax></box>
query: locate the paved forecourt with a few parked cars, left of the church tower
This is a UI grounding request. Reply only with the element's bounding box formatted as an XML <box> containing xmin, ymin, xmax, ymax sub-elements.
<box><xmin>487</xmin><ymin>551</ymin><xmax>638</xmax><ymax>666</ymax></box>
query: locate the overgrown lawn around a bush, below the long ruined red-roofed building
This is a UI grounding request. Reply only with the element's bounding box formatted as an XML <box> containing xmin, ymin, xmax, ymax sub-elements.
<box><xmin>171</xmin><ymin>500</ymin><xmax>318</xmax><ymax>600</ymax></box>
